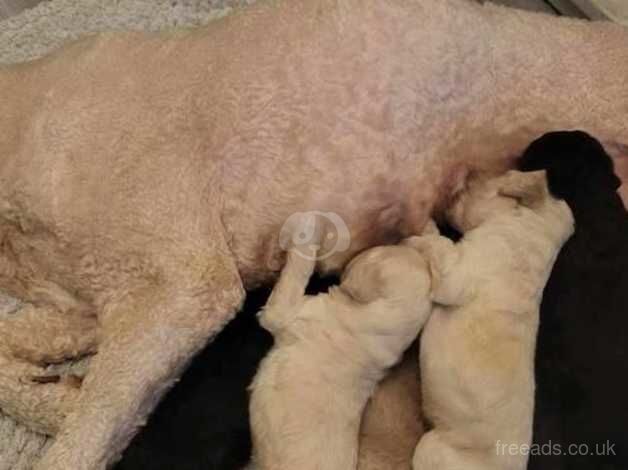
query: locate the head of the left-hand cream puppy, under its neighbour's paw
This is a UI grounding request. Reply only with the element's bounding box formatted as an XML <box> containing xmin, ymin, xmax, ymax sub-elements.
<box><xmin>340</xmin><ymin>246</ymin><xmax>431</xmax><ymax>303</ymax></box>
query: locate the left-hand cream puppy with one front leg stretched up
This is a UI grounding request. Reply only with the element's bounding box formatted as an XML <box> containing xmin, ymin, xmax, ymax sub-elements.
<box><xmin>250</xmin><ymin>241</ymin><xmax>431</xmax><ymax>470</ymax></box>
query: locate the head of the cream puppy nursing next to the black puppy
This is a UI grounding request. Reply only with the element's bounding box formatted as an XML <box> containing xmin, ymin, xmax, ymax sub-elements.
<box><xmin>446</xmin><ymin>171</ymin><xmax>548</xmax><ymax>233</ymax></box>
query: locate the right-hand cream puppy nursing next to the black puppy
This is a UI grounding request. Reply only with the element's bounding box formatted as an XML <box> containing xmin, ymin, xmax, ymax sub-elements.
<box><xmin>413</xmin><ymin>171</ymin><xmax>573</xmax><ymax>470</ymax></box>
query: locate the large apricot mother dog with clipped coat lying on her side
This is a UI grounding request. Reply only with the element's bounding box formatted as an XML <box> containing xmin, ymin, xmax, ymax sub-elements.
<box><xmin>0</xmin><ymin>0</ymin><xmax>628</xmax><ymax>470</ymax></box>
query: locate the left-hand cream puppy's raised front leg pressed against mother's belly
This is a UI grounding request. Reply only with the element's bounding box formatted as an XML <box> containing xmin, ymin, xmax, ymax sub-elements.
<box><xmin>259</xmin><ymin>245</ymin><xmax>318</xmax><ymax>335</ymax></box>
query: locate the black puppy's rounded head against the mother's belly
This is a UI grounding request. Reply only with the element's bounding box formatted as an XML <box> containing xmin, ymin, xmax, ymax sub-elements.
<box><xmin>519</xmin><ymin>131</ymin><xmax>621</xmax><ymax>202</ymax></box>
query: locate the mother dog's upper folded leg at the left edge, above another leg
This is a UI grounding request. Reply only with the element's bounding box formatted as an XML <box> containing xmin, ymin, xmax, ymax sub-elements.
<box><xmin>0</xmin><ymin>304</ymin><xmax>100</xmax><ymax>365</ymax></box>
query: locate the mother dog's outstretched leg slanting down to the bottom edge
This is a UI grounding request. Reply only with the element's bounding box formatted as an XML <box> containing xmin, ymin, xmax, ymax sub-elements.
<box><xmin>35</xmin><ymin>252</ymin><xmax>244</xmax><ymax>470</ymax></box>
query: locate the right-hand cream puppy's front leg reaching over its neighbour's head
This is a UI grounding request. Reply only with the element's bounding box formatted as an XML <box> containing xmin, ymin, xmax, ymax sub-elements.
<box><xmin>404</xmin><ymin>234</ymin><xmax>473</xmax><ymax>306</ymax></box>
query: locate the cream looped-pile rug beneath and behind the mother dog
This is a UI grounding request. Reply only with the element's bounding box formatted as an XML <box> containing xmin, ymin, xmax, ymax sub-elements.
<box><xmin>0</xmin><ymin>0</ymin><xmax>251</xmax><ymax>470</ymax></box>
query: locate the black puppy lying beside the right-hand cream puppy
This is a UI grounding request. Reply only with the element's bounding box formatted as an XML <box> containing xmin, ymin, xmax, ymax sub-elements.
<box><xmin>520</xmin><ymin>132</ymin><xmax>628</xmax><ymax>470</ymax></box>
